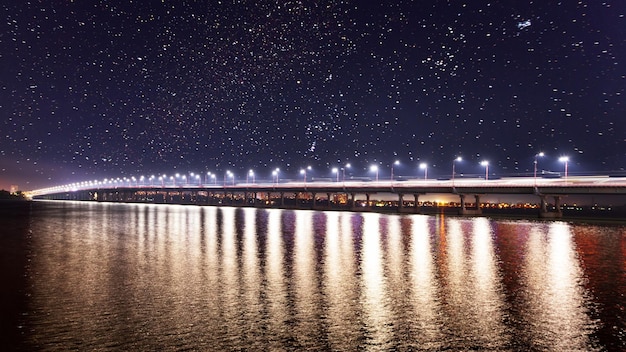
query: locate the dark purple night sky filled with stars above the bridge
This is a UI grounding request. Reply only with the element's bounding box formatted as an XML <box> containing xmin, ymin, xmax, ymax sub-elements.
<box><xmin>0</xmin><ymin>0</ymin><xmax>626</xmax><ymax>190</ymax></box>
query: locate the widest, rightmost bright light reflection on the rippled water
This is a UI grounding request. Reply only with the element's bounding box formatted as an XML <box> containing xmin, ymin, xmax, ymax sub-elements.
<box><xmin>524</xmin><ymin>223</ymin><xmax>595</xmax><ymax>351</ymax></box>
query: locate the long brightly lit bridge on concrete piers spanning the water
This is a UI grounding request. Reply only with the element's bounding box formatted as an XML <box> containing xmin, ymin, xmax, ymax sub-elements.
<box><xmin>29</xmin><ymin>176</ymin><xmax>626</xmax><ymax>218</ymax></box>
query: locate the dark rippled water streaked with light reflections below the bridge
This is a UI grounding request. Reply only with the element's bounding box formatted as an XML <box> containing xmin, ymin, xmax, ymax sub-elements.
<box><xmin>0</xmin><ymin>202</ymin><xmax>626</xmax><ymax>351</ymax></box>
